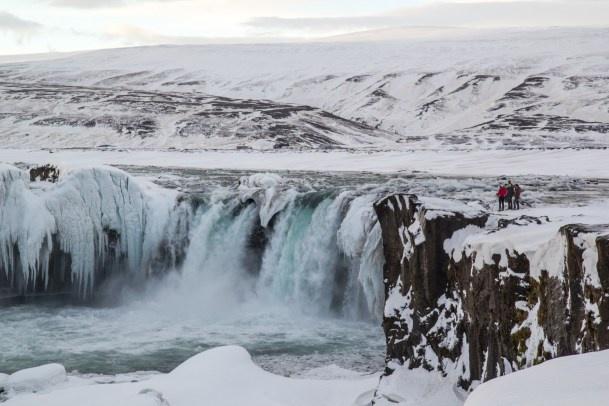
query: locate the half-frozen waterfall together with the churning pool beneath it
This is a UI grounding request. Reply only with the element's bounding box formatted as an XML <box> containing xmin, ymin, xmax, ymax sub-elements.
<box><xmin>0</xmin><ymin>166</ymin><xmax>384</xmax><ymax>374</ymax></box>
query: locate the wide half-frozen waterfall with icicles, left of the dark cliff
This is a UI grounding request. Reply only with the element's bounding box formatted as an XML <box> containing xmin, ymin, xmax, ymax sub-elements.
<box><xmin>0</xmin><ymin>166</ymin><xmax>383</xmax><ymax>319</ymax></box>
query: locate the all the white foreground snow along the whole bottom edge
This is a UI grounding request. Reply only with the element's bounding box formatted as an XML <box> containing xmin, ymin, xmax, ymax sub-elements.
<box><xmin>19</xmin><ymin>340</ymin><xmax>609</xmax><ymax>406</ymax></box>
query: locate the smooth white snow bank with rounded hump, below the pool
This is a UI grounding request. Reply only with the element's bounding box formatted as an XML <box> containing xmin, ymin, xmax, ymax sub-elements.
<box><xmin>6</xmin><ymin>346</ymin><xmax>378</xmax><ymax>406</ymax></box>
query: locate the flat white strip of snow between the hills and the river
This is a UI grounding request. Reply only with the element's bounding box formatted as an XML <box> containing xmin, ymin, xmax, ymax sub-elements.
<box><xmin>0</xmin><ymin>149</ymin><xmax>609</xmax><ymax>178</ymax></box>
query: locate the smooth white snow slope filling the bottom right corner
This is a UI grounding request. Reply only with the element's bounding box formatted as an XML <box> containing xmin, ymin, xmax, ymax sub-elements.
<box><xmin>465</xmin><ymin>351</ymin><xmax>609</xmax><ymax>406</ymax></box>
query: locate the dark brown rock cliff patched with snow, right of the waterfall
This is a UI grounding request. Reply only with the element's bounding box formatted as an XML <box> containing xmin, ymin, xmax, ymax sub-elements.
<box><xmin>375</xmin><ymin>195</ymin><xmax>609</xmax><ymax>389</ymax></box>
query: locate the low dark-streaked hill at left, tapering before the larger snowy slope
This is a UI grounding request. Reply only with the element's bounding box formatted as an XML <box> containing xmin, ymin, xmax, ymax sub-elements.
<box><xmin>0</xmin><ymin>83</ymin><xmax>395</xmax><ymax>149</ymax></box>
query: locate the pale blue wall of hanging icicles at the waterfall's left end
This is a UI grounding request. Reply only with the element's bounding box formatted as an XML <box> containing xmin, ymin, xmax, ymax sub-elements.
<box><xmin>0</xmin><ymin>166</ymin><xmax>176</xmax><ymax>297</ymax></box>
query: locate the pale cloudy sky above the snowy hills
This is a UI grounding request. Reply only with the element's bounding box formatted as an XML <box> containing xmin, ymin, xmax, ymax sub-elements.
<box><xmin>0</xmin><ymin>0</ymin><xmax>609</xmax><ymax>55</ymax></box>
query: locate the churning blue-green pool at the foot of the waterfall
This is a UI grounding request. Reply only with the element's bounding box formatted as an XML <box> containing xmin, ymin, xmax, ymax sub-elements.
<box><xmin>0</xmin><ymin>303</ymin><xmax>384</xmax><ymax>376</ymax></box>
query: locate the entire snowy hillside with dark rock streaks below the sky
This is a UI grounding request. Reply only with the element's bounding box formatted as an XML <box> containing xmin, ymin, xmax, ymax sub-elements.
<box><xmin>0</xmin><ymin>29</ymin><xmax>609</xmax><ymax>149</ymax></box>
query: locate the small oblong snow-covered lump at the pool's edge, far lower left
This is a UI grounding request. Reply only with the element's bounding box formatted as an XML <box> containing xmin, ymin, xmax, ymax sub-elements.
<box><xmin>5</xmin><ymin>364</ymin><xmax>67</xmax><ymax>393</ymax></box>
